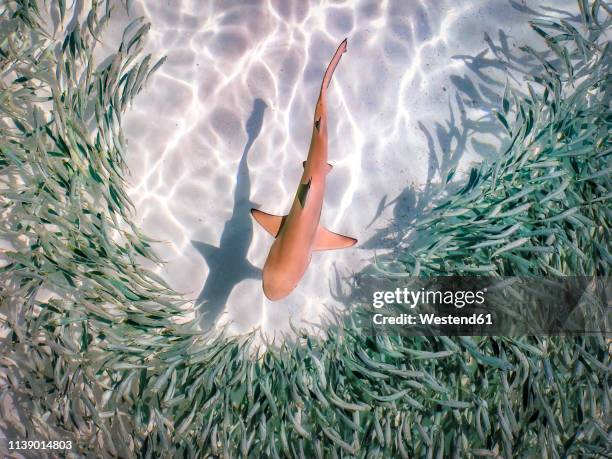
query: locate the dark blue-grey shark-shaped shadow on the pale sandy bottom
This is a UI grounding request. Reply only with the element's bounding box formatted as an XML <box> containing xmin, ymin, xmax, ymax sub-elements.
<box><xmin>191</xmin><ymin>99</ymin><xmax>267</xmax><ymax>329</ymax></box>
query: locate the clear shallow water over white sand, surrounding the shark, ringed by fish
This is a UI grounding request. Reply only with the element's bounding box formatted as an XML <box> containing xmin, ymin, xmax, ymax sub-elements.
<box><xmin>125</xmin><ymin>0</ymin><xmax>575</xmax><ymax>333</ymax></box>
